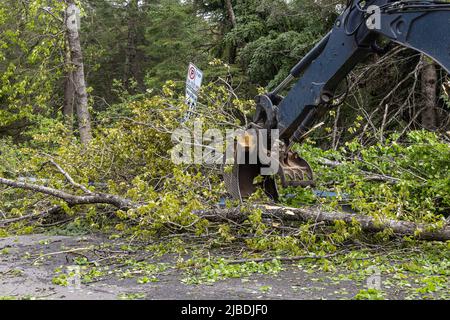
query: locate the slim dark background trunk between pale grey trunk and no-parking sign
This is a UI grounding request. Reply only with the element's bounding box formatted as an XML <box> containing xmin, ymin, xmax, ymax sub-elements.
<box><xmin>123</xmin><ymin>0</ymin><xmax>139</xmax><ymax>89</ymax></box>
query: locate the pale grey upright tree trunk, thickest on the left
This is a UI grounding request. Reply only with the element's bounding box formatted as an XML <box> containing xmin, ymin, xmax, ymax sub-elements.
<box><xmin>66</xmin><ymin>0</ymin><xmax>92</xmax><ymax>145</ymax></box>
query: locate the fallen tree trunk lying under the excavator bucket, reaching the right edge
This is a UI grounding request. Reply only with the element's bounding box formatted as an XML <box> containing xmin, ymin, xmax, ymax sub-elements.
<box><xmin>197</xmin><ymin>205</ymin><xmax>450</xmax><ymax>241</ymax></box>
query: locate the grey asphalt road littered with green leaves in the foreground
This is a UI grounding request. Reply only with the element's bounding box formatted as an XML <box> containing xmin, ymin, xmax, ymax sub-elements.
<box><xmin>0</xmin><ymin>235</ymin><xmax>442</xmax><ymax>300</ymax></box>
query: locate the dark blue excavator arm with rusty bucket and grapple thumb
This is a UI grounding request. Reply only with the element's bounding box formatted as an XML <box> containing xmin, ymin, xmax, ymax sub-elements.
<box><xmin>225</xmin><ymin>0</ymin><xmax>450</xmax><ymax>200</ymax></box>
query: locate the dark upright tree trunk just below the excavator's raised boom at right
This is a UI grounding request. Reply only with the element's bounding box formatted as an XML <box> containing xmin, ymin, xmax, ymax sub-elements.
<box><xmin>421</xmin><ymin>55</ymin><xmax>438</xmax><ymax>130</ymax></box>
